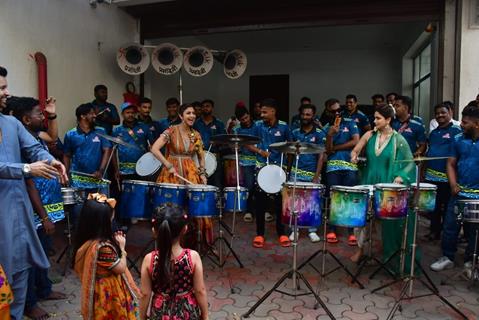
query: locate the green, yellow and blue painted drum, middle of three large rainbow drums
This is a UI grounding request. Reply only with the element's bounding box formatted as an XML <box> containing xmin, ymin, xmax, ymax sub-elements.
<box><xmin>329</xmin><ymin>186</ymin><xmax>369</xmax><ymax>228</ymax></box>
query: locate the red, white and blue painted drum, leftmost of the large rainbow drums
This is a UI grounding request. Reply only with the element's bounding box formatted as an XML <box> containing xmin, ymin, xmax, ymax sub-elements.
<box><xmin>281</xmin><ymin>182</ymin><xmax>324</xmax><ymax>228</ymax></box>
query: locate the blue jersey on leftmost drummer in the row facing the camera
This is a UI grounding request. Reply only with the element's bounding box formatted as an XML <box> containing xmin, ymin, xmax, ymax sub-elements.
<box><xmin>63</xmin><ymin>127</ymin><xmax>111</xmax><ymax>189</ymax></box>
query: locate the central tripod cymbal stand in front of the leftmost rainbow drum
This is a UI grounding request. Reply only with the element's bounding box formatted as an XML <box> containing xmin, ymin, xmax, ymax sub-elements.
<box><xmin>243</xmin><ymin>146</ymin><xmax>336</xmax><ymax>320</ymax></box>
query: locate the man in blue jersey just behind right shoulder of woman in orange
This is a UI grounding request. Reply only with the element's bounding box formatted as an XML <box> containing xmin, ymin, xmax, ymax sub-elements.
<box><xmin>193</xmin><ymin>99</ymin><xmax>226</xmax><ymax>189</ymax></box>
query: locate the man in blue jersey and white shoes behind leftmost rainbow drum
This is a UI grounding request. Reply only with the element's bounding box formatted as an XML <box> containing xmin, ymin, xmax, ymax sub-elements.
<box><xmin>289</xmin><ymin>104</ymin><xmax>326</xmax><ymax>242</ymax></box>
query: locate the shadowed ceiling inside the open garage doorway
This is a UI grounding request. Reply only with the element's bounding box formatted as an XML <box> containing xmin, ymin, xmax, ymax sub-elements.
<box><xmin>149</xmin><ymin>22</ymin><xmax>427</xmax><ymax>53</ymax></box>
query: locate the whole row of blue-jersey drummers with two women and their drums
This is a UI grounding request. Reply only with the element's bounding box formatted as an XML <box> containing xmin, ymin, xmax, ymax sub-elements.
<box><xmin>9</xmin><ymin>85</ymin><xmax>479</xmax><ymax>278</ymax></box>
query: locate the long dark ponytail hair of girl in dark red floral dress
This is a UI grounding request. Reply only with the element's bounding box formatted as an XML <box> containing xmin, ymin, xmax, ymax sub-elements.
<box><xmin>152</xmin><ymin>204</ymin><xmax>188</xmax><ymax>289</ymax></box>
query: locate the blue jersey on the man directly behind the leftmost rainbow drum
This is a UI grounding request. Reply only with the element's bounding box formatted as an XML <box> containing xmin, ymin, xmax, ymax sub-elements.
<box><xmin>291</xmin><ymin>128</ymin><xmax>326</xmax><ymax>182</ymax></box>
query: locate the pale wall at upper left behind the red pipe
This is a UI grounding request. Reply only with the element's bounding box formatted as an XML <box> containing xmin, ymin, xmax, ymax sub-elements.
<box><xmin>0</xmin><ymin>0</ymin><xmax>138</xmax><ymax>135</ymax></box>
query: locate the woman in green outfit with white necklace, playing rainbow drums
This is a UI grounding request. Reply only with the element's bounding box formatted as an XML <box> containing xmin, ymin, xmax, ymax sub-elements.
<box><xmin>351</xmin><ymin>105</ymin><xmax>416</xmax><ymax>270</ymax></box>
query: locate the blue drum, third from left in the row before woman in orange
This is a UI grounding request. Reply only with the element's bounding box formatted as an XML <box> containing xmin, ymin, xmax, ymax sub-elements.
<box><xmin>188</xmin><ymin>185</ymin><xmax>218</xmax><ymax>218</ymax></box>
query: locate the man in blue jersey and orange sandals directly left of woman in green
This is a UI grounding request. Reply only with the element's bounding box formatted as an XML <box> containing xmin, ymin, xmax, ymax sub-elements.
<box><xmin>323</xmin><ymin>103</ymin><xmax>359</xmax><ymax>246</ymax></box>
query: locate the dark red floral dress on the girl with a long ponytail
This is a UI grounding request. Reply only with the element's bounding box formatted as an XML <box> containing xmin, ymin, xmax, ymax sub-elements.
<box><xmin>147</xmin><ymin>249</ymin><xmax>201</xmax><ymax>320</ymax></box>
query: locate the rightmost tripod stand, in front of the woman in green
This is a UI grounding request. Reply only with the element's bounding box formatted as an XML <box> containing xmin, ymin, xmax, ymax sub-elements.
<box><xmin>373</xmin><ymin>162</ymin><xmax>468</xmax><ymax>320</ymax></box>
